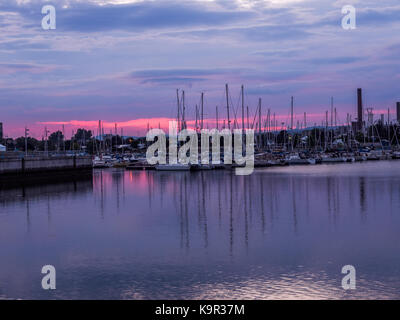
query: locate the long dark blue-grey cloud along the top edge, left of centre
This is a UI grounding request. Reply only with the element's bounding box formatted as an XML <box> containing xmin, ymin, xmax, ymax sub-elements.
<box><xmin>5</xmin><ymin>0</ymin><xmax>254</xmax><ymax>32</ymax></box>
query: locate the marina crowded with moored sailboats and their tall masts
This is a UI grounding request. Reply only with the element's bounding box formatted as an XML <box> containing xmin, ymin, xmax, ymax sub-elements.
<box><xmin>86</xmin><ymin>85</ymin><xmax>400</xmax><ymax>171</ymax></box>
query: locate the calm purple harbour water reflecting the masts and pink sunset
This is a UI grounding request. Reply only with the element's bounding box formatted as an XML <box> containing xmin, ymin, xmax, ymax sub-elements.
<box><xmin>0</xmin><ymin>161</ymin><xmax>400</xmax><ymax>299</ymax></box>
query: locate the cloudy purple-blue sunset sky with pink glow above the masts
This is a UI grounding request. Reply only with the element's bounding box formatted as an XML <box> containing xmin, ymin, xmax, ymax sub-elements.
<box><xmin>0</xmin><ymin>0</ymin><xmax>400</xmax><ymax>138</ymax></box>
